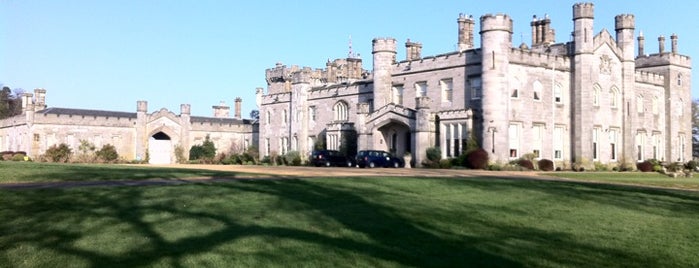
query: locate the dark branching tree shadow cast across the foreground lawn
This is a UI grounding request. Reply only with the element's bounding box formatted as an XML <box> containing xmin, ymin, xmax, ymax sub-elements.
<box><xmin>0</xmin><ymin>176</ymin><xmax>696</xmax><ymax>267</ymax></box>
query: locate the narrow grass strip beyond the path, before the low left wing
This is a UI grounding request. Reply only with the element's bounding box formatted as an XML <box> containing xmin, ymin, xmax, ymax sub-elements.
<box><xmin>0</xmin><ymin>161</ymin><xmax>239</xmax><ymax>183</ymax></box>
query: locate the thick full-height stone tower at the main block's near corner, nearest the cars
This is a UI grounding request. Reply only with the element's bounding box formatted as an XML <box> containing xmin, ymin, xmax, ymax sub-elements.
<box><xmin>480</xmin><ymin>14</ymin><xmax>512</xmax><ymax>160</ymax></box>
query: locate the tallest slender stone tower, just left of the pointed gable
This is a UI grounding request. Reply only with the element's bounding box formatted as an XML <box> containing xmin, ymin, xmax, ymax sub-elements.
<box><xmin>576</xmin><ymin>3</ymin><xmax>595</xmax><ymax>161</ymax></box>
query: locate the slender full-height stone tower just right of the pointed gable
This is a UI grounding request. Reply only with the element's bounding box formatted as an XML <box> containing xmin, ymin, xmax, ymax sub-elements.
<box><xmin>614</xmin><ymin>14</ymin><xmax>639</xmax><ymax>166</ymax></box>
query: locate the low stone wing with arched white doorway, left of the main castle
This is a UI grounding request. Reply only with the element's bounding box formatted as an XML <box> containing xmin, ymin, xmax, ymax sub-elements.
<box><xmin>0</xmin><ymin>89</ymin><xmax>258</xmax><ymax>164</ymax></box>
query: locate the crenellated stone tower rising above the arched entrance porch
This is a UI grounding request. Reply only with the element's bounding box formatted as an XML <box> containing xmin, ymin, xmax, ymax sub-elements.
<box><xmin>371</xmin><ymin>38</ymin><xmax>396</xmax><ymax>110</ymax></box>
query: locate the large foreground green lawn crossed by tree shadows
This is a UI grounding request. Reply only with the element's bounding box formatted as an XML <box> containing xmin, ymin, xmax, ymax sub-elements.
<box><xmin>0</xmin><ymin>164</ymin><xmax>699</xmax><ymax>267</ymax></box>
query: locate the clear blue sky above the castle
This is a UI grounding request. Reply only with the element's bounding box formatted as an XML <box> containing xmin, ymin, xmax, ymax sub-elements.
<box><xmin>0</xmin><ymin>0</ymin><xmax>699</xmax><ymax>118</ymax></box>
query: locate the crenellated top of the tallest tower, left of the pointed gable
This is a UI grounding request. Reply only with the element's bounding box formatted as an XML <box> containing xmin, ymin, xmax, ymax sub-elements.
<box><xmin>573</xmin><ymin>3</ymin><xmax>595</xmax><ymax>54</ymax></box>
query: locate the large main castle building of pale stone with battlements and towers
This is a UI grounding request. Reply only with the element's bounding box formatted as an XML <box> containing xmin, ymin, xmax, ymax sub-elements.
<box><xmin>257</xmin><ymin>3</ymin><xmax>692</xmax><ymax>168</ymax></box>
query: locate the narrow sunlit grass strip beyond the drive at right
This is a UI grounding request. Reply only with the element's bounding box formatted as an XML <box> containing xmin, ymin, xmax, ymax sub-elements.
<box><xmin>544</xmin><ymin>172</ymin><xmax>699</xmax><ymax>190</ymax></box>
